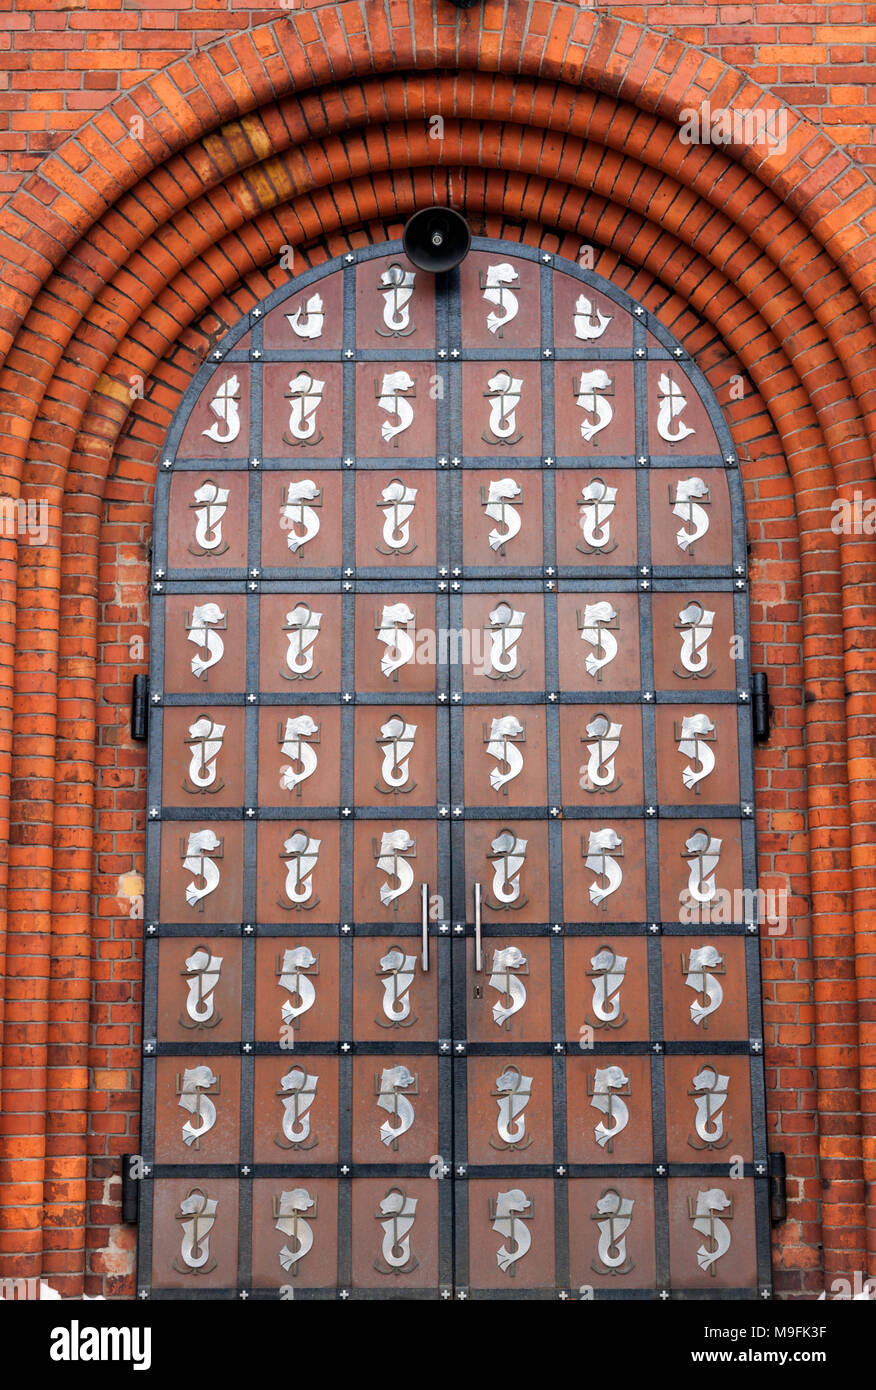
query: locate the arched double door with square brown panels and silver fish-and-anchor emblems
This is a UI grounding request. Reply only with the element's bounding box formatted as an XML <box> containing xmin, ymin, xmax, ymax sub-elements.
<box><xmin>139</xmin><ymin>239</ymin><xmax>769</xmax><ymax>1298</ymax></box>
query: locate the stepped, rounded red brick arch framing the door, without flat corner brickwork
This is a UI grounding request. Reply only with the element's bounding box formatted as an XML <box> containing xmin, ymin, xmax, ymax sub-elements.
<box><xmin>0</xmin><ymin>0</ymin><xmax>876</xmax><ymax>1291</ymax></box>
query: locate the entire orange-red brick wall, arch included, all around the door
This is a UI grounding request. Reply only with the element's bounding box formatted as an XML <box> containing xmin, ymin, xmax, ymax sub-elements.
<box><xmin>0</xmin><ymin>0</ymin><xmax>876</xmax><ymax>1297</ymax></box>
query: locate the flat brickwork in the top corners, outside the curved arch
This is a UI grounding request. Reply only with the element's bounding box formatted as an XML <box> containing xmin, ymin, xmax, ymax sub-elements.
<box><xmin>0</xmin><ymin>0</ymin><xmax>876</xmax><ymax>196</ymax></box>
